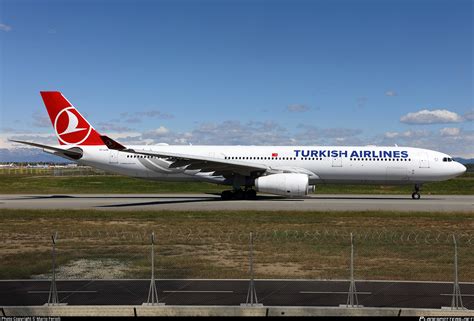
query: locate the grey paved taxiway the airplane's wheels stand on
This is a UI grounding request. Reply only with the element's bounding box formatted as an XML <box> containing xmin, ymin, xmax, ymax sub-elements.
<box><xmin>0</xmin><ymin>194</ymin><xmax>474</xmax><ymax>212</ymax></box>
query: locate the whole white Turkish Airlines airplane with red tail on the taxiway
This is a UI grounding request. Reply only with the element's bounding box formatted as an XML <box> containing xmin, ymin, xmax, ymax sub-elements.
<box><xmin>11</xmin><ymin>91</ymin><xmax>466</xmax><ymax>200</ymax></box>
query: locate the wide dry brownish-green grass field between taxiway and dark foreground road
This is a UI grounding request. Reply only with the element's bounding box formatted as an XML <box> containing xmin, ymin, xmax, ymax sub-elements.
<box><xmin>0</xmin><ymin>210</ymin><xmax>474</xmax><ymax>281</ymax></box>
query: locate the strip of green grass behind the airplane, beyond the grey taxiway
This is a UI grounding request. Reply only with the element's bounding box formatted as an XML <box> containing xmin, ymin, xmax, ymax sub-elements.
<box><xmin>0</xmin><ymin>173</ymin><xmax>474</xmax><ymax>195</ymax></box>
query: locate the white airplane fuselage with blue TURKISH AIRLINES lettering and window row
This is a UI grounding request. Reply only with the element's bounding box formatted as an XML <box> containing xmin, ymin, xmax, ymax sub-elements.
<box><xmin>71</xmin><ymin>145</ymin><xmax>466</xmax><ymax>185</ymax></box>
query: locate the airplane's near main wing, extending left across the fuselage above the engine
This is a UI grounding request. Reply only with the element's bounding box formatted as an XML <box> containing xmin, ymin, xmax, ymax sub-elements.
<box><xmin>121</xmin><ymin>148</ymin><xmax>270</xmax><ymax>177</ymax></box>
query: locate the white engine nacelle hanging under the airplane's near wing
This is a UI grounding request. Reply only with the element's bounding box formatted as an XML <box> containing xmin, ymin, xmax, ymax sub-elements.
<box><xmin>255</xmin><ymin>174</ymin><xmax>309</xmax><ymax>197</ymax></box>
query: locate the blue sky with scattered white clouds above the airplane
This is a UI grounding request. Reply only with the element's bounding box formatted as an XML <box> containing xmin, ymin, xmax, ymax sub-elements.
<box><xmin>0</xmin><ymin>0</ymin><xmax>474</xmax><ymax>157</ymax></box>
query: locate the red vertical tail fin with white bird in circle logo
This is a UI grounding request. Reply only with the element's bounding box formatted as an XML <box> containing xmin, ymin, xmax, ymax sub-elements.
<box><xmin>41</xmin><ymin>91</ymin><xmax>104</xmax><ymax>145</ymax></box>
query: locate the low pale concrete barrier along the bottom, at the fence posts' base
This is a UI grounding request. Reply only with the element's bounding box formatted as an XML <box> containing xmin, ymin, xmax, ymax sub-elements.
<box><xmin>2</xmin><ymin>305</ymin><xmax>474</xmax><ymax>317</ymax></box>
